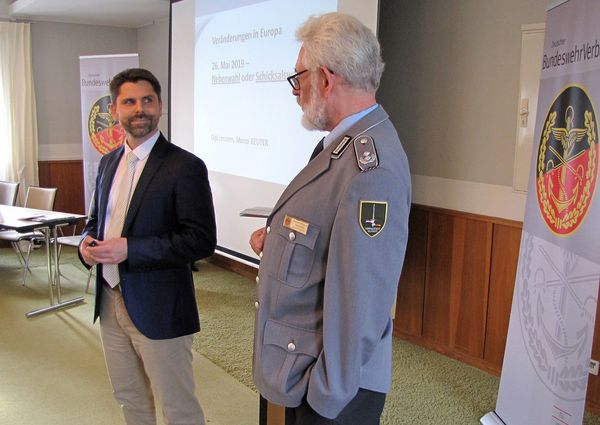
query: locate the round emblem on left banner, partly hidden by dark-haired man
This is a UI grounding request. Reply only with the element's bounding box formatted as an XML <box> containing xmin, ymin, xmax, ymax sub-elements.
<box><xmin>88</xmin><ymin>95</ymin><xmax>126</xmax><ymax>155</ymax></box>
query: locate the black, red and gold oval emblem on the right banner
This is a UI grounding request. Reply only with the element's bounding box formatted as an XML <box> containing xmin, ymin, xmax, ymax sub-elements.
<box><xmin>536</xmin><ymin>85</ymin><xmax>598</xmax><ymax>236</ymax></box>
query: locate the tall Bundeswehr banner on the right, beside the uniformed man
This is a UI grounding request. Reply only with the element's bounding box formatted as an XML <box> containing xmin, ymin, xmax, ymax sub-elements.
<box><xmin>481</xmin><ymin>0</ymin><xmax>600</xmax><ymax>425</ymax></box>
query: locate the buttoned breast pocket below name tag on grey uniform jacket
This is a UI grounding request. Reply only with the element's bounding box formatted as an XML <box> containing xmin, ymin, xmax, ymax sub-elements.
<box><xmin>277</xmin><ymin>224</ymin><xmax>320</xmax><ymax>288</ymax></box>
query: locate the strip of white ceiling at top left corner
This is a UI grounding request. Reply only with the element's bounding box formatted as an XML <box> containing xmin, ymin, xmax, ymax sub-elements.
<box><xmin>0</xmin><ymin>0</ymin><xmax>170</xmax><ymax>28</ymax></box>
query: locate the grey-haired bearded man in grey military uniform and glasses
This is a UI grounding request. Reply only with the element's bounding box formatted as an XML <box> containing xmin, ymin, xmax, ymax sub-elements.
<box><xmin>250</xmin><ymin>13</ymin><xmax>411</xmax><ymax>425</ymax></box>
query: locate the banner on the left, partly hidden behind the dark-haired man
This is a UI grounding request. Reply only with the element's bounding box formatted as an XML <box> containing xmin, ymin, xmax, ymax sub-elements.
<box><xmin>79</xmin><ymin>53</ymin><xmax>139</xmax><ymax>208</ymax></box>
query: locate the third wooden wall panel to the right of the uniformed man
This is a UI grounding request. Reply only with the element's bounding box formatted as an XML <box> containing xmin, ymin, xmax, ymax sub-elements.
<box><xmin>450</xmin><ymin>218</ymin><xmax>493</xmax><ymax>359</ymax></box>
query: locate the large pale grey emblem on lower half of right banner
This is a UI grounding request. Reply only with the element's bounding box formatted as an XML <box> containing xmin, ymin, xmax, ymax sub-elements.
<box><xmin>515</xmin><ymin>230</ymin><xmax>600</xmax><ymax>400</ymax></box>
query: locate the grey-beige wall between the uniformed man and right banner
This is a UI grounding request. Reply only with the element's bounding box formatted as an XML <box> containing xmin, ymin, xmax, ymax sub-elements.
<box><xmin>378</xmin><ymin>0</ymin><xmax>547</xmax><ymax>220</ymax></box>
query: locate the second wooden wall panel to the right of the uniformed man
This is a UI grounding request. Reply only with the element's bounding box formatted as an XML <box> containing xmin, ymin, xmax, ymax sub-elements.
<box><xmin>423</xmin><ymin>212</ymin><xmax>454</xmax><ymax>346</ymax></box>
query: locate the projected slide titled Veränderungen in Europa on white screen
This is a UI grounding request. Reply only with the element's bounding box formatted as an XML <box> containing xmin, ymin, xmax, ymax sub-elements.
<box><xmin>194</xmin><ymin>0</ymin><xmax>337</xmax><ymax>184</ymax></box>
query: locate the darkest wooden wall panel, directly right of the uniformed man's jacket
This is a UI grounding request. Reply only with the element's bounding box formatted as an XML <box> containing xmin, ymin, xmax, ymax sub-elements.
<box><xmin>394</xmin><ymin>208</ymin><xmax>429</xmax><ymax>337</ymax></box>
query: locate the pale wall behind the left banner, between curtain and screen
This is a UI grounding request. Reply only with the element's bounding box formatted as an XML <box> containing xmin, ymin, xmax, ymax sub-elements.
<box><xmin>31</xmin><ymin>20</ymin><xmax>169</xmax><ymax>161</ymax></box>
